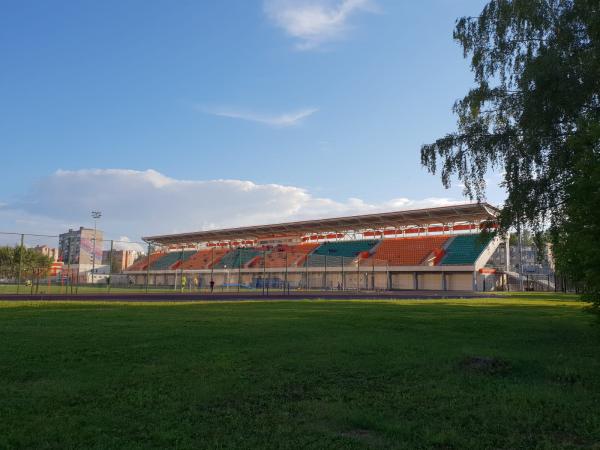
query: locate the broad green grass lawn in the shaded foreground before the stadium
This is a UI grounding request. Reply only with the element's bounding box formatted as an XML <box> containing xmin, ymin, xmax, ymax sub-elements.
<box><xmin>0</xmin><ymin>294</ymin><xmax>600</xmax><ymax>449</ymax></box>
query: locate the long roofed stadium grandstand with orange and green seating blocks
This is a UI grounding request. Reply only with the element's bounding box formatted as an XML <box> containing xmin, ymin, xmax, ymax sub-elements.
<box><xmin>125</xmin><ymin>203</ymin><xmax>508</xmax><ymax>291</ymax></box>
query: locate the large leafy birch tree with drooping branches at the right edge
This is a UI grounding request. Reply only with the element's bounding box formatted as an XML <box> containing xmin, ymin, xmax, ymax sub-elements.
<box><xmin>421</xmin><ymin>0</ymin><xmax>600</xmax><ymax>308</ymax></box>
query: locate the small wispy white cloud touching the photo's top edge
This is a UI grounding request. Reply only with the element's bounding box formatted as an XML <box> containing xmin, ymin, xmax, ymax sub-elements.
<box><xmin>264</xmin><ymin>0</ymin><xmax>376</xmax><ymax>50</ymax></box>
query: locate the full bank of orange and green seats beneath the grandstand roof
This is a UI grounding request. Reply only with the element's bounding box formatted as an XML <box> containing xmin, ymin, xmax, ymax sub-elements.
<box><xmin>123</xmin><ymin>234</ymin><xmax>491</xmax><ymax>271</ymax></box>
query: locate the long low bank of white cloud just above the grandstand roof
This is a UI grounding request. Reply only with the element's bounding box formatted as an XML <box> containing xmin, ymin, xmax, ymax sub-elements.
<box><xmin>0</xmin><ymin>169</ymin><xmax>464</xmax><ymax>248</ymax></box>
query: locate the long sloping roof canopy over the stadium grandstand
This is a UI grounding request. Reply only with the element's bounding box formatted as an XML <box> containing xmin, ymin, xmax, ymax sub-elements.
<box><xmin>143</xmin><ymin>203</ymin><xmax>499</xmax><ymax>245</ymax></box>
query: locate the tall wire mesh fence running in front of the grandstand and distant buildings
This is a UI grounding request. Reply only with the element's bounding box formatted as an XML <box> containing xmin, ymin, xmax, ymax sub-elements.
<box><xmin>0</xmin><ymin>232</ymin><xmax>576</xmax><ymax>295</ymax></box>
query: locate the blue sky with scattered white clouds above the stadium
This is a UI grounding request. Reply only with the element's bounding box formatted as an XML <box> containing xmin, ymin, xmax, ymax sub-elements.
<box><xmin>0</xmin><ymin>0</ymin><xmax>504</xmax><ymax>246</ymax></box>
